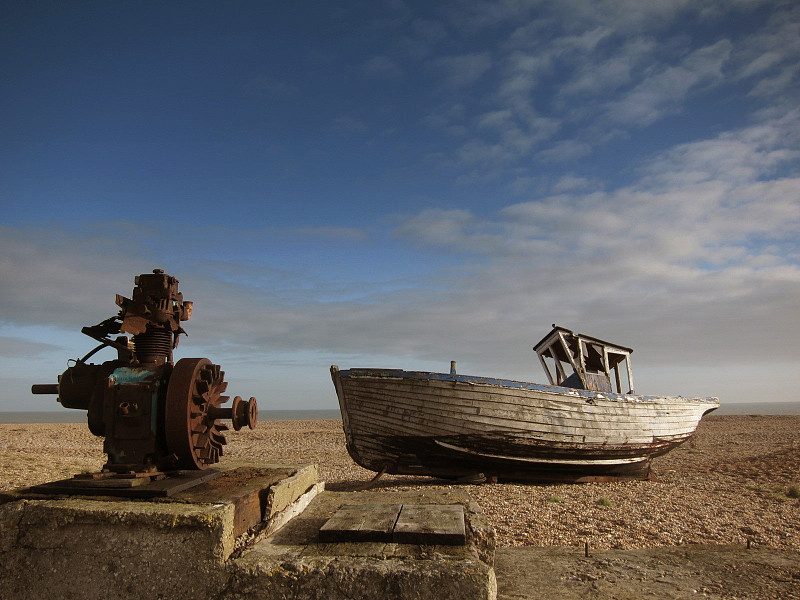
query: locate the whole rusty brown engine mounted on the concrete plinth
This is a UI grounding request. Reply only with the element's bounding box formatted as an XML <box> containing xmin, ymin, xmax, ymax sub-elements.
<box><xmin>31</xmin><ymin>269</ymin><xmax>258</xmax><ymax>488</ymax></box>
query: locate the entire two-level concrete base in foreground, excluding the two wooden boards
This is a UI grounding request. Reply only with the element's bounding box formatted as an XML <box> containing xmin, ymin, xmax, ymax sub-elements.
<box><xmin>0</xmin><ymin>464</ymin><xmax>497</xmax><ymax>600</ymax></box>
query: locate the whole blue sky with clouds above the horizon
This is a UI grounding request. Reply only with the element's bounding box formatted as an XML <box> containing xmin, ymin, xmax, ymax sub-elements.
<box><xmin>0</xmin><ymin>0</ymin><xmax>800</xmax><ymax>410</ymax></box>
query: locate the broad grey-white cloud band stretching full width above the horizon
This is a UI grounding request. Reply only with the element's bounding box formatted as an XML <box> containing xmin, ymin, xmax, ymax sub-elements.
<box><xmin>0</xmin><ymin>121</ymin><xmax>800</xmax><ymax>408</ymax></box>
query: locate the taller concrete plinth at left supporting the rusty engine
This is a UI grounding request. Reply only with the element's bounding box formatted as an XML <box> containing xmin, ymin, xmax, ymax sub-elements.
<box><xmin>0</xmin><ymin>463</ymin><xmax>323</xmax><ymax>600</ymax></box>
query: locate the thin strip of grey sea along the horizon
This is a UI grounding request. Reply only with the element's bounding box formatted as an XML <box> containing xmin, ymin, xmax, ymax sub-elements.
<box><xmin>0</xmin><ymin>402</ymin><xmax>800</xmax><ymax>424</ymax></box>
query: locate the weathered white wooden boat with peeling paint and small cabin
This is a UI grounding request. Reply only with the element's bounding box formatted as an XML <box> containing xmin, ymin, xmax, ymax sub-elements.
<box><xmin>331</xmin><ymin>325</ymin><xmax>719</xmax><ymax>482</ymax></box>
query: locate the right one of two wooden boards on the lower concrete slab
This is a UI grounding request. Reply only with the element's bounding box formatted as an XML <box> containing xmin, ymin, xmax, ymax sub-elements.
<box><xmin>392</xmin><ymin>504</ymin><xmax>467</xmax><ymax>546</ymax></box>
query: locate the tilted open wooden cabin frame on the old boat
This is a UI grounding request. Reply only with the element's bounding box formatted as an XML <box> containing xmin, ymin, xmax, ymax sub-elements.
<box><xmin>533</xmin><ymin>324</ymin><xmax>635</xmax><ymax>394</ymax></box>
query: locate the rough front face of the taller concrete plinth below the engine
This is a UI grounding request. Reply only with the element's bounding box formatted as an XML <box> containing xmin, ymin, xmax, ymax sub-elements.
<box><xmin>0</xmin><ymin>498</ymin><xmax>233</xmax><ymax>600</ymax></box>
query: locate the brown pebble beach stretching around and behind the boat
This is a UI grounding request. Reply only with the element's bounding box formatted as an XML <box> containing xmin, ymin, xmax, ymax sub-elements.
<box><xmin>0</xmin><ymin>414</ymin><xmax>800</xmax><ymax>552</ymax></box>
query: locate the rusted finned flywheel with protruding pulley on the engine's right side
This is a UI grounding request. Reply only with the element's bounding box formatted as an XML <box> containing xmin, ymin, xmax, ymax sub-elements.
<box><xmin>164</xmin><ymin>358</ymin><xmax>258</xmax><ymax>469</ymax></box>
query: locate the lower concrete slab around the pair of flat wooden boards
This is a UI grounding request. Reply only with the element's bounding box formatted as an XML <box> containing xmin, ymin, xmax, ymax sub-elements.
<box><xmin>224</xmin><ymin>489</ymin><xmax>497</xmax><ymax>600</ymax></box>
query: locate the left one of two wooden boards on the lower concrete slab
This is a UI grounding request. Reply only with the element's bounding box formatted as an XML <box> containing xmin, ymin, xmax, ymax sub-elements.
<box><xmin>319</xmin><ymin>504</ymin><xmax>402</xmax><ymax>542</ymax></box>
